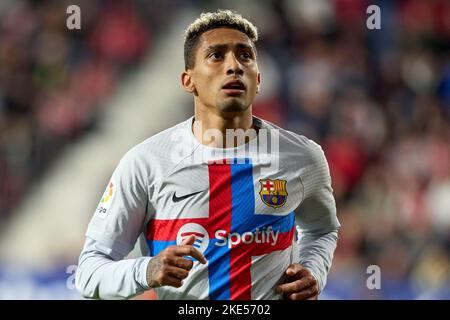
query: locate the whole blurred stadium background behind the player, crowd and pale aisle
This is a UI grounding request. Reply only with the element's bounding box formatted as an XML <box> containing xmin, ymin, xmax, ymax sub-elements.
<box><xmin>0</xmin><ymin>0</ymin><xmax>450</xmax><ymax>299</ymax></box>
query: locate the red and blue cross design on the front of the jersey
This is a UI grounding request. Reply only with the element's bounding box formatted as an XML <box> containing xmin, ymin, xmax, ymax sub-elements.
<box><xmin>147</xmin><ymin>159</ymin><xmax>295</xmax><ymax>300</ymax></box>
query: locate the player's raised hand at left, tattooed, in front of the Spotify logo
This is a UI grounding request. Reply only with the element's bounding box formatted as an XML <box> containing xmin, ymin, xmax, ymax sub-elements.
<box><xmin>147</xmin><ymin>235</ymin><xmax>206</xmax><ymax>288</ymax></box>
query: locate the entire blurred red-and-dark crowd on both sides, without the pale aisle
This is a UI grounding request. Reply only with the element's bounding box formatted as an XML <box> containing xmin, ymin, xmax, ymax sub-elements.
<box><xmin>0</xmin><ymin>0</ymin><xmax>450</xmax><ymax>299</ymax></box>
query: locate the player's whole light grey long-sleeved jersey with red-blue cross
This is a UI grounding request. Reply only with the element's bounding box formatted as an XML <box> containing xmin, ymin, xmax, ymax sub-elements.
<box><xmin>76</xmin><ymin>117</ymin><xmax>340</xmax><ymax>300</ymax></box>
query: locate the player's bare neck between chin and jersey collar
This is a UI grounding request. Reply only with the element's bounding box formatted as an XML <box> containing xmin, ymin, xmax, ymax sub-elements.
<box><xmin>192</xmin><ymin>106</ymin><xmax>257</xmax><ymax>148</ymax></box>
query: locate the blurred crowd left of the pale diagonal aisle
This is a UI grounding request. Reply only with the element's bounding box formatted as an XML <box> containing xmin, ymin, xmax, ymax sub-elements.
<box><xmin>0</xmin><ymin>0</ymin><xmax>184</xmax><ymax>219</ymax></box>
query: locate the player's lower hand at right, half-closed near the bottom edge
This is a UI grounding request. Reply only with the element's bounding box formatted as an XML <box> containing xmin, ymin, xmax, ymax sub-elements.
<box><xmin>277</xmin><ymin>263</ymin><xmax>319</xmax><ymax>300</ymax></box>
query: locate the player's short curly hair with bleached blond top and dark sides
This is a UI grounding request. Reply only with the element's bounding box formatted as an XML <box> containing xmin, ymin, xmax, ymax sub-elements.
<box><xmin>184</xmin><ymin>9</ymin><xmax>258</xmax><ymax>70</ymax></box>
